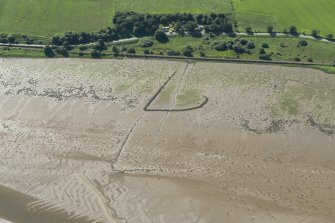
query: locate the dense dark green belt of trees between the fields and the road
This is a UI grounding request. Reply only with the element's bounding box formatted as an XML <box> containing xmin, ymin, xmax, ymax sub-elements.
<box><xmin>51</xmin><ymin>11</ymin><xmax>233</xmax><ymax>47</ymax></box>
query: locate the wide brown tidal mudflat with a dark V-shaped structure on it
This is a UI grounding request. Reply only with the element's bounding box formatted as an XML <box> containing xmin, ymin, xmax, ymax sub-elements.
<box><xmin>0</xmin><ymin>59</ymin><xmax>335</xmax><ymax>223</ymax></box>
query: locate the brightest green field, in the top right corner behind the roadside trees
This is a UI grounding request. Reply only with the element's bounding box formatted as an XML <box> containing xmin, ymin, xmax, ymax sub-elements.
<box><xmin>232</xmin><ymin>0</ymin><xmax>335</xmax><ymax>35</ymax></box>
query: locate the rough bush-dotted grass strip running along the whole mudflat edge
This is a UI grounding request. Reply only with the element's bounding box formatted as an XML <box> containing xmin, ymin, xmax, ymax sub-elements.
<box><xmin>0</xmin><ymin>36</ymin><xmax>335</xmax><ymax>65</ymax></box>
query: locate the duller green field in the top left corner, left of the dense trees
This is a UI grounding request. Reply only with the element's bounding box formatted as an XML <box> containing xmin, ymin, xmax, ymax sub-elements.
<box><xmin>0</xmin><ymin>0</ymin><xmax>114</xmax><ymax>36</ymax></box>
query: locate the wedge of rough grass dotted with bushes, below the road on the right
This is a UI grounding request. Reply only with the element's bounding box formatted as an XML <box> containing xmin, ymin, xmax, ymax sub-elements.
<box><xmin>104</xmin><ymin>36</ymin><xmax>335</xmax><ymax>64</ymax></box>
